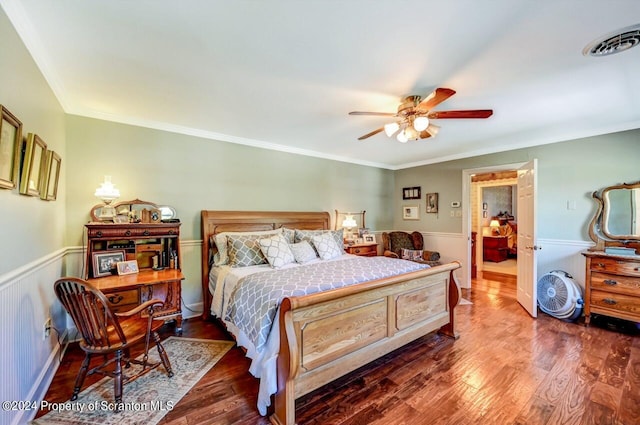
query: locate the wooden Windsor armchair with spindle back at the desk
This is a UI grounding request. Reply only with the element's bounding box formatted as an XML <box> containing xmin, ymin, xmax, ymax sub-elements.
<box><xmin>54</xmin><ymin>277</ymin><xmax>173</xmax><ymax>403</ymax></box>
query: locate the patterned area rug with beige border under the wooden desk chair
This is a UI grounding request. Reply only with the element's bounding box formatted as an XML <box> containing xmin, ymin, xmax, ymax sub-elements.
<box><xmin>31</xmin><ymin>336</ymin><xmax>234</xmax><ymax>425</ymax></box>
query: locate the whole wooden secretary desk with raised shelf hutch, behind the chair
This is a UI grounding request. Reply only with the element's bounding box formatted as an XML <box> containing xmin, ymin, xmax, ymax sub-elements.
<box><xmin>85</xmin><ymin>223</ymin><xmax>184</xmax><ymax>332</ymax></box>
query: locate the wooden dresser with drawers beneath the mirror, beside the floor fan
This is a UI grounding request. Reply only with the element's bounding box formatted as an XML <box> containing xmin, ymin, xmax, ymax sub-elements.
<box><xmin>582</xmin><ymin>251</ymin><xmax>640</xmax><ymax>325</ymax></box>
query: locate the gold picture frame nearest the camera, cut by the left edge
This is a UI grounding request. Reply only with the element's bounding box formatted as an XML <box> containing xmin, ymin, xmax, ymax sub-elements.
<box><xmin>0</xmin><ymin>105</ymin><xmax>22</xmax><ymax>189</ymax></box>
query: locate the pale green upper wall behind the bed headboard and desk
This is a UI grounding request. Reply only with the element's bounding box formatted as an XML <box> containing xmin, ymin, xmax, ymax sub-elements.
<box><xmin>67</xmin><ymin>116</ymin><xmax>394</xmax><ymax>245</ymax></box>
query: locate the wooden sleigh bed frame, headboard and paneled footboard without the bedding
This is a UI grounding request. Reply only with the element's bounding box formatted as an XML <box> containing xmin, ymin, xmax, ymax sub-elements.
<box><xmin>202</xmin><ymin>210</ymin><xmax>460</xmax><ymax>425</ymax></box>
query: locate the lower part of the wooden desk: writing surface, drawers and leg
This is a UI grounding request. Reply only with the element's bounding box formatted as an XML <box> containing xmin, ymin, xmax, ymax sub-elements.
<box><xmin>88</xmin><ymin>269</ymin><xmax>184</xmax><ymax>333</ymax></box>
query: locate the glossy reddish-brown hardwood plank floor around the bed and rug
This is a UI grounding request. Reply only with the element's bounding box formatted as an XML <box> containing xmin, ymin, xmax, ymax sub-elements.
<box><xmin>41</xmin><ymin>277</ymin><xmax>640</xmax><ymax>425</ymax></box>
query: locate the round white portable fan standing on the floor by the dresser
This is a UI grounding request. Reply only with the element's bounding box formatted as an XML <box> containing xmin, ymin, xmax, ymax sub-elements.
<box><xmin>538</xmin><ymin>270</ymin><xmax>584</xmax><ymax>321</ymax></box>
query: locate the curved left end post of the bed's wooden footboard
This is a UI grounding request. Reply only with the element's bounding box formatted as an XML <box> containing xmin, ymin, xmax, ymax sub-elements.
<box><xmin>269</xmin><ymin>298</ymin><xmax>298</xmax><ymax>425</ymax></box>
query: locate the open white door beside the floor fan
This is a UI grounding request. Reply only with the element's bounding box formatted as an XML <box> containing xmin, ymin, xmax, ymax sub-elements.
<box><xmin>517</xmin><ymin>159</ymin><xmax>542</xmax><ymax>317</ymax></box>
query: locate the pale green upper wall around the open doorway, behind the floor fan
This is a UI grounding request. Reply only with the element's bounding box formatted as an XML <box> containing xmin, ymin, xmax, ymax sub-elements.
<box><xmin>393</xmin><ymin>130</ymin><xmax>640</xmax><ymax>241</ymax></box>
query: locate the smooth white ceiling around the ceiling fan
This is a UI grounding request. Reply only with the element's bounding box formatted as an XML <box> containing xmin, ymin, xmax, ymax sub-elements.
<box><xmin>5</xmin><ymin>0</ymin><xmax>640</xmax><ymax>169</ymax></box>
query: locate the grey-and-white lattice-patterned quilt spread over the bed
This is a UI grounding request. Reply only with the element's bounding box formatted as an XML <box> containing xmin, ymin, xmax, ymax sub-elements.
<box><xmin>225</xmin><ymin>257</ymin><xmax>429</xmax><ymax>352</ymax></box>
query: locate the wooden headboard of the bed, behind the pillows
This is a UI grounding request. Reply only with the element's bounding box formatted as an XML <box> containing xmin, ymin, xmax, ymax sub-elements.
<box><xmin>201</xmin><ymin>210</ymin><xmax>330</xmax><ymax>319</ymax></box>
